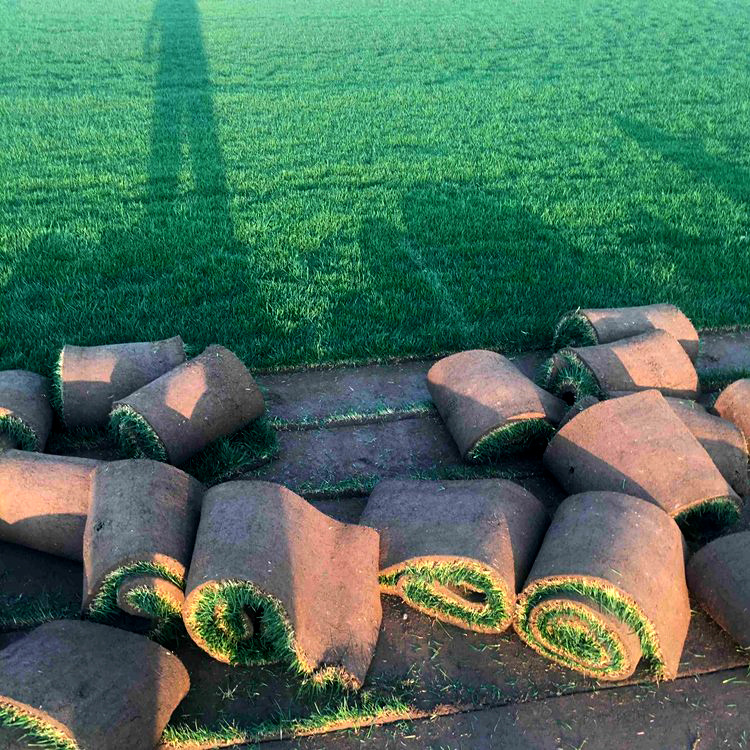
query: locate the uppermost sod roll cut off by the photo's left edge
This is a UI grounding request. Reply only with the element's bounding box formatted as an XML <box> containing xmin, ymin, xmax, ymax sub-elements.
<box><xmin>0</xmin><ymin>370</ymin><xmax>52</xmax><ymax>451</ymax></box>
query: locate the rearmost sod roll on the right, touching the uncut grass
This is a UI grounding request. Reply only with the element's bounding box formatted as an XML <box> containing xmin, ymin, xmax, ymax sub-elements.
<box><xmin>553</xmin><ymin>304</ymin><xmax>698</xmax><ymax>362</ymax></box>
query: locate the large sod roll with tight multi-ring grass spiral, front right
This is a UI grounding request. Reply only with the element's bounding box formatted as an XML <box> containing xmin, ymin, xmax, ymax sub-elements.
<box><xmin>514</xmin><ymin>492</ymin><xmax>690</xmax><ymax>680</ymax></box>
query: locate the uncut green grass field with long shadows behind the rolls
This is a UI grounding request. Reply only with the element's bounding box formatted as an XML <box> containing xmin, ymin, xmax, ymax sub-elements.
<box><xmin>0</xmin><ymin>0</ymin><xmax>750</xmax><ymax>370</ymax></box>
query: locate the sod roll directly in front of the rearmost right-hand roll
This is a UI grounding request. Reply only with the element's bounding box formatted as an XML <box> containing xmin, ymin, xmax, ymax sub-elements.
<box><xmin>540</xmin><ymin>331</ymin><xmax>700</xmax><ymax>403</ymax></box>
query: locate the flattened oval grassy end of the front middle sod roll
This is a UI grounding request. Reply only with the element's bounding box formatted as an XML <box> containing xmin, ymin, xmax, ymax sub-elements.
<box><xmin>378</xmin><ymin>560</ymin><xmax>515</xmax><ymax>633</ymax></box>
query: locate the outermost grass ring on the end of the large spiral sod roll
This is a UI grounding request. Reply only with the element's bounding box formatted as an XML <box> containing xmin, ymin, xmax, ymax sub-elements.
<box><xmin>514</xmin><ymin>576</ymin><xmax>665</xmax><ymax>679</ymax></box>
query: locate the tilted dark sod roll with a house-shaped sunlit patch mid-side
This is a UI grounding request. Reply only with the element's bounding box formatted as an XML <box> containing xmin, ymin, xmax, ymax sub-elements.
<box><xmin>110</xmin><ymin>346</ymin><xmax>265</xmax><ymax>465</ymax></box>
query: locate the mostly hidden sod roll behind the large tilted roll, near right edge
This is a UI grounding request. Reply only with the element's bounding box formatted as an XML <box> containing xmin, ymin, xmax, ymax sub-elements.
<box><xmin>667</xmin><ymin>398</ymin><xmax>750</xmax><ymax>496</ymax></box>
